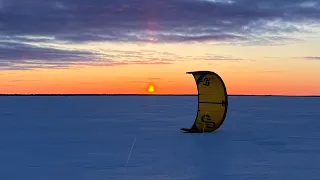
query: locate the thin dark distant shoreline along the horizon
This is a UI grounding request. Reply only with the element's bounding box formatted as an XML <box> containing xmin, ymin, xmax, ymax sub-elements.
<box><xmin>0</xmin><ymin>94</ymin><xmax>320</xmax><ymax>97</ymax></box>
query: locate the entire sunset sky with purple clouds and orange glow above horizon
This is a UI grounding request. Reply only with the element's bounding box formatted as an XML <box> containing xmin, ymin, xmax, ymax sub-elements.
<box><xmin>0</xmin><ymin>0</ymin><xmax>320</xmax><ymax>95</ymax></box>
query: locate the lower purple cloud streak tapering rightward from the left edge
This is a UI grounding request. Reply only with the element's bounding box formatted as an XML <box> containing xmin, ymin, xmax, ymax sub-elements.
<box><xmin>0</xmin><ymin>41</ymin><xmax>178</xmax><ymax>70</ymax></box>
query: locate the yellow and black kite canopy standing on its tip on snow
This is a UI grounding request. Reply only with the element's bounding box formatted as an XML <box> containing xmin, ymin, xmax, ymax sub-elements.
<box><xmin>181</xmin><ymin>71</ymin><xmax>228</xmax><ymax>133</ymax></box>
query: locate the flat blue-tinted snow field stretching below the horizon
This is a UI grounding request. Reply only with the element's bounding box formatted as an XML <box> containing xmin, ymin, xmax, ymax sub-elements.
<box><xmin>0</xmin><ymin>96</ymin><xmax>320</xmax><ymax>180</ymax></box>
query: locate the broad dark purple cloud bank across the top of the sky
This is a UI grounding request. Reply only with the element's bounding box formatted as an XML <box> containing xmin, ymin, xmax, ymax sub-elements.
<box><xmin>0</xmin><ymin>0</ymin><xmax>320</xmax><ymax>42</ymax></box>
